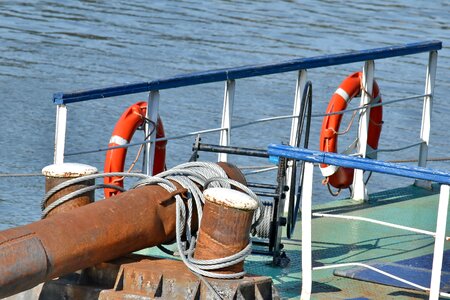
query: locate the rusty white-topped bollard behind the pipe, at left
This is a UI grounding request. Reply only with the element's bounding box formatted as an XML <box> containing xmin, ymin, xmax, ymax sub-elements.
<box><xmin>42</xmin><ymin>163</ymin><xmax>97</xmax><ymax>217</ymax></box>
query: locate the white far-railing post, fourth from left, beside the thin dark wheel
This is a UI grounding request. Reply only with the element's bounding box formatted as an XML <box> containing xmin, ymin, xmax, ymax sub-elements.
<box><xmin>284</xmin><ymin>70</ymin><xmax>307</xmax><ymax>213</ymax></box>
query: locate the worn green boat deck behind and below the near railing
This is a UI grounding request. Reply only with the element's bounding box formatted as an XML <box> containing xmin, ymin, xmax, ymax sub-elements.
<box><xmin>245</xmin><ymin>186</ymin><xmax>450</xmax><ymax>299</ymax></box>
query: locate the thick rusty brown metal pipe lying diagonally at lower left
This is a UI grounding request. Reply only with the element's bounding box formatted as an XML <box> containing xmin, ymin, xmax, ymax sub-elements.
<box><xmin>0</xmin><ymin>165</ymin><xmax>245</xmax><ymax>298</ymax></box>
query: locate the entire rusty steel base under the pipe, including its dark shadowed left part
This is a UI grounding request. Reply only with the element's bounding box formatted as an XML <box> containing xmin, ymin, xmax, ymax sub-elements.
<box><xmin>26</xmin><ymin>254</ymin><xmax>279</xmax><ymax>300</ymax></box>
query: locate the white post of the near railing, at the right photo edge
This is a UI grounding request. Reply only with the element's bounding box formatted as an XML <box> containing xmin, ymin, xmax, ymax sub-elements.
<box><xmin>430</xmin><ymin>184</ymin><xmax>450</xmax><ymax>300</ymax></box>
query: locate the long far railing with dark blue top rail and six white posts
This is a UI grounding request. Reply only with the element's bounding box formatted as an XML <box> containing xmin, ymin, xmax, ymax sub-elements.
<box><xmin>53</xmin><ymin>40</ymin><xmax>442</xmax><ymax>205</ymax></box>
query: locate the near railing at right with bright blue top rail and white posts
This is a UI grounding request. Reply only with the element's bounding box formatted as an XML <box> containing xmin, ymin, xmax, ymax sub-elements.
<box><xmin>268</xmin><ymin>144</ymin><xmax>450</xmax><ymax>299</ymax></box>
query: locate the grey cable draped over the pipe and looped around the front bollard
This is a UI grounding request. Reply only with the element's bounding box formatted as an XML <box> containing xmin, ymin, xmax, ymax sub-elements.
<box><xmin>41</xmin><ymin>162</ymin><xmax>264</xmax><ymax>298</ymax></box>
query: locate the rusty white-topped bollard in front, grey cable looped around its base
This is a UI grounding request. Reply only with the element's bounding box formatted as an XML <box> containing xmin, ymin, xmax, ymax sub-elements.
<box><xmin>194</xmin><ymin>188</ymin><xmax>258</xmax><ymax>274</ymax></box>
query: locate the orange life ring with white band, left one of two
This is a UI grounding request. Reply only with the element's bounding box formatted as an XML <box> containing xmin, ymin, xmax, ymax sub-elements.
<box><xmin>104</xmin><ymin>101</ymin><xmax>167</xmax><ymax>198</ymax></box>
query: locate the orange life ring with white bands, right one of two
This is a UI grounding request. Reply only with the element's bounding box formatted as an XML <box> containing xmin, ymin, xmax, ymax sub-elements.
<box><xmin>320</xmin><ymin>72</ymin><xmax>383</xmax><ymax>189</ymax></box>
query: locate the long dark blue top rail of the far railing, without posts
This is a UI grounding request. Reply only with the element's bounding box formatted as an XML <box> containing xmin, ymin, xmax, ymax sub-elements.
<box><xmin>53</xmin><ymin>41</ymin><xmax>442</xmax><ymax>104</ymax></box>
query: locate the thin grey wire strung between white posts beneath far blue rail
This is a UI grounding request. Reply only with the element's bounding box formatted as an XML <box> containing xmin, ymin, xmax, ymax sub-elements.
<box><xmin>64</xmin><ymin>94</ymin><xmax>431</xmax><ymax>156</ymax></box>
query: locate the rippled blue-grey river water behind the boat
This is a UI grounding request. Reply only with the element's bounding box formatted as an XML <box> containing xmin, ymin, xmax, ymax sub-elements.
<box><xmin>0</xmin><ymin>0</ymin><xmax>450</xmax><ymax>229</ymax></box>
